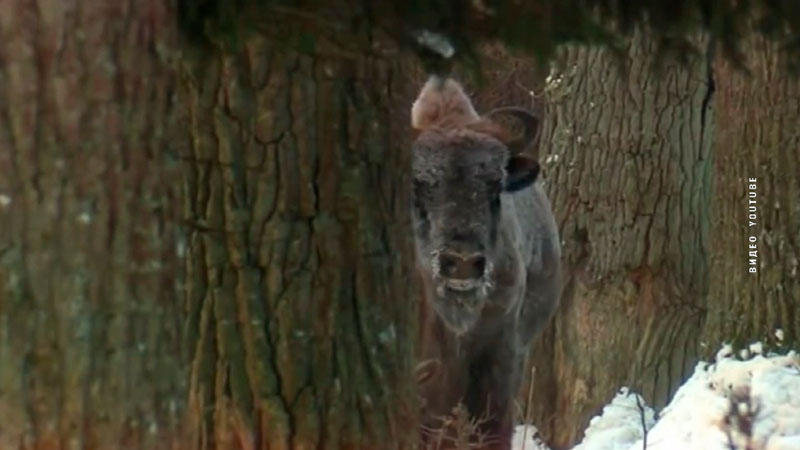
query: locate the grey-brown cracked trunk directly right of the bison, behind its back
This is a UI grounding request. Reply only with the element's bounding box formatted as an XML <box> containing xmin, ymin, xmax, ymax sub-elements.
<box><xmin>531</xmin><ymin>32</ymin><xmax>713</xmax><ymax>448</ymax></box>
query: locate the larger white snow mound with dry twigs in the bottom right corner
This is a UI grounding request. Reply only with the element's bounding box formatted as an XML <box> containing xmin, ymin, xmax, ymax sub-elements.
<box><xmin>632</xmin><ymin>353</ymin><xmax>800</xmax><ymax>450</ymax></box>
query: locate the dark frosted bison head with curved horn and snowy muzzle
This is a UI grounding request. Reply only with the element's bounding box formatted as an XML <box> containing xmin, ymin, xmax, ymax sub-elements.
<box><xmin>411</xmin><ymin>78</ymin><xmax>539</xmax><ymax>333</ymax></box>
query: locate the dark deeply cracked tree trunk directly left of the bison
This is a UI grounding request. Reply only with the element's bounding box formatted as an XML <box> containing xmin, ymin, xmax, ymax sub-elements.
<box><xmin>182</xmin><ymin>37</ymin><xmax>416</xmax><ymax>449</ymax></box>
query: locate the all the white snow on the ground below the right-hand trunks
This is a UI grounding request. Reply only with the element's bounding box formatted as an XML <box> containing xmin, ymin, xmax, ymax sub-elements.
<box><xmin>514</xmin><ymin>344</ymin><xmax>800</xmax><ymax>450</ymax></box>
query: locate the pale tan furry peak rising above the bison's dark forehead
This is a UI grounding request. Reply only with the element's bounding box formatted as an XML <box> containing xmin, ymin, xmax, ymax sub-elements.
<box><xmin>411</xmin><ymin>76</ymin><xmax>479</xmax><ymax>130</ymax></box>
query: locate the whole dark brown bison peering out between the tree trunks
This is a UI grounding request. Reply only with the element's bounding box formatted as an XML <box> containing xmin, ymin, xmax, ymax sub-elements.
<box><xmin>411</xmin><ymin>77</ymin><xmax>561</xmax><ymax>449</ymax></box>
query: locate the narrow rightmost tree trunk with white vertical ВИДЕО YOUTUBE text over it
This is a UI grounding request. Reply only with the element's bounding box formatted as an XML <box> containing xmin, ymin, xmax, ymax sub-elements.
<box><xmin>705</xmin><ymin>37</ymin><xmax>800</xmax><ymax>353</ymax></box>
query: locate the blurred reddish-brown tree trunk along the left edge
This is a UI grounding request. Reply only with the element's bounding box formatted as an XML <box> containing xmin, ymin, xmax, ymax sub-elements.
<box><xmin>0</xmin><ymin>0</ymin><xmax>186</xmax><ymax>450</ymax></box>
